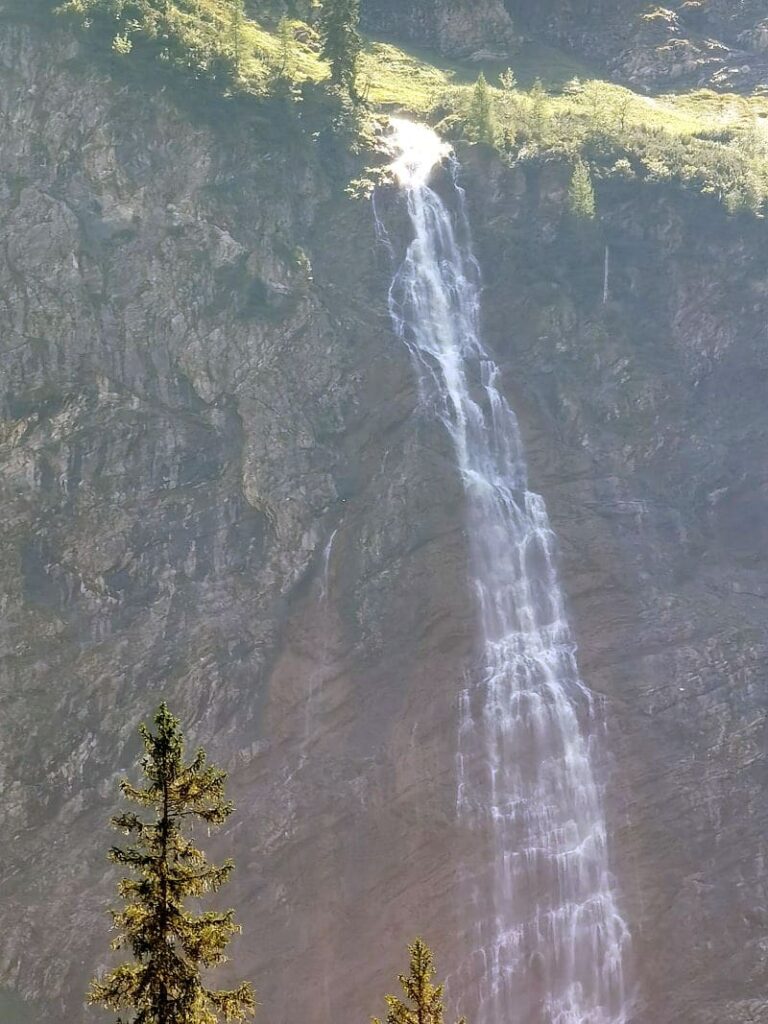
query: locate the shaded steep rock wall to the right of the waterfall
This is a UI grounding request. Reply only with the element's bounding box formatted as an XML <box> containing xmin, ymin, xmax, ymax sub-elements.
<box><xmin>462</xmin><ymin>149</ymin><xmax>768</xmax><ymax>1024</ymax></box>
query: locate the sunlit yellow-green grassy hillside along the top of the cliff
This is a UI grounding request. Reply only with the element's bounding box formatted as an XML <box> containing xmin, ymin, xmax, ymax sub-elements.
<box><xmin>40</xmin><ymin>0</ymin><xmax>768</xmax><ymax>213</ymax></box>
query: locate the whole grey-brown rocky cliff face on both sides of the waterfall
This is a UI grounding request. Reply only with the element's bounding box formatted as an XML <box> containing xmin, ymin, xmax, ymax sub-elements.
<box><xmin>0</xmin><ymin>8</ymin><xmax>768</xmax><ymax>1024</ymax></box>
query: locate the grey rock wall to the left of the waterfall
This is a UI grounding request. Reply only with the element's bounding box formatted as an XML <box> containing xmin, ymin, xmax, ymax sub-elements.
<box><xmin>0</xmin><ymin>12</ymin><xmax>471</xmax><ymax>1024</ymax></box>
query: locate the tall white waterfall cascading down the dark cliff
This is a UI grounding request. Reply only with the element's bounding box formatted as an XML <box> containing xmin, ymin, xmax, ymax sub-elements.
<box><xmin>380</xmin><ymin>121</ymin><xmax>629</xmax><ymax>1024</ymax></box>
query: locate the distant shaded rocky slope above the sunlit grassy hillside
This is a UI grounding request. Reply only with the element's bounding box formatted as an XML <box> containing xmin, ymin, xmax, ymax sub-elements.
<box><xmin>362</xmin><ymin>0</ymin><xmax>768</xmax><ymax>90</ymax></box>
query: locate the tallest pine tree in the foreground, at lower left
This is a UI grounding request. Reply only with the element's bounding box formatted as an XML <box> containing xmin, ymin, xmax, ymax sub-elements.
<box><xmin>88</xmin><ymin>703</ymin><xmax>255</xmax><ymax>1024</ymax></box>
